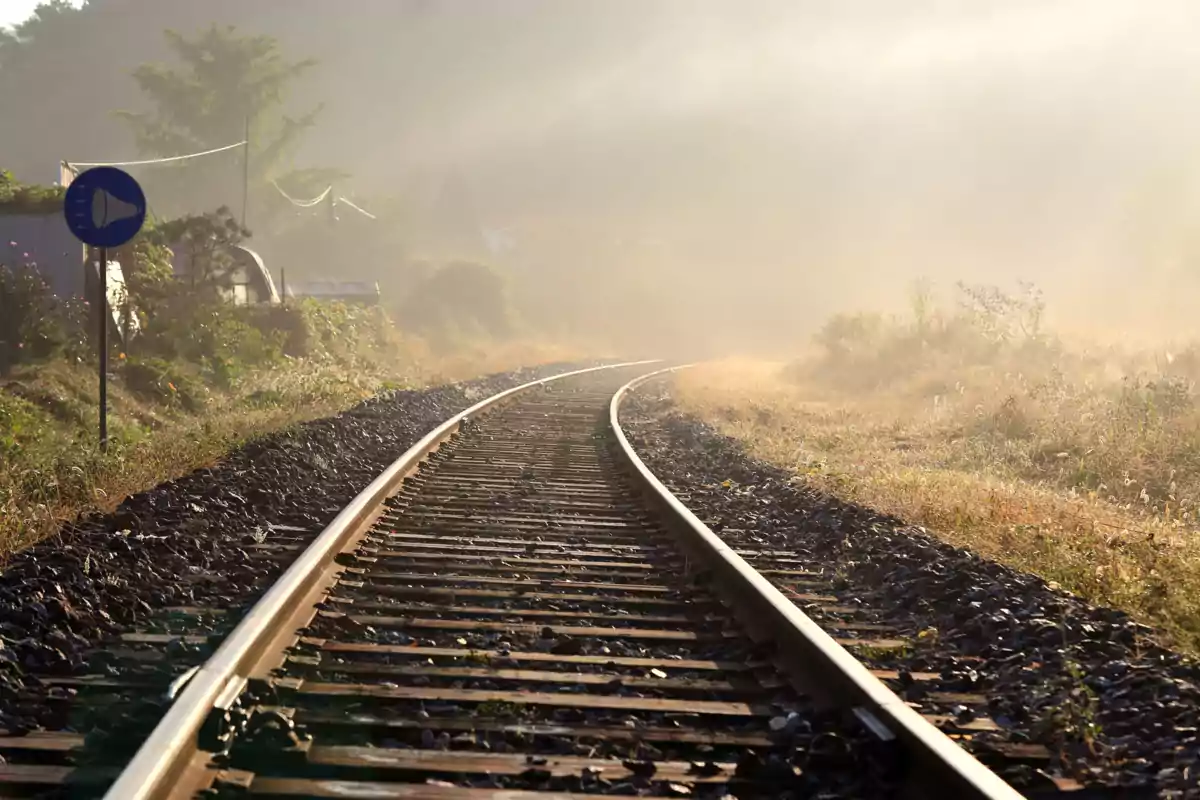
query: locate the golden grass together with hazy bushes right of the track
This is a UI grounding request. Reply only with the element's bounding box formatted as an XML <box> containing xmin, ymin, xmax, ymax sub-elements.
<box><xmin>677</xmin><ymin>285</ymin><xmax>1200</xmax><ymax>652</ymax></box>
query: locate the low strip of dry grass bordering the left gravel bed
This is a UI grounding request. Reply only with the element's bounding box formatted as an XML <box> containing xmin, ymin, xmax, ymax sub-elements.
<box><xmin>0</xmin><ymin>339</ymin><xmax>577</xmax><ymax>558</ymax></box>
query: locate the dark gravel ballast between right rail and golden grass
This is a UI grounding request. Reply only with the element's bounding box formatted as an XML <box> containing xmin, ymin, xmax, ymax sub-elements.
<box><xmin>622</xmin><ymin>380</ymin><xmax>1200</xmax><ymax>798</ymax></box>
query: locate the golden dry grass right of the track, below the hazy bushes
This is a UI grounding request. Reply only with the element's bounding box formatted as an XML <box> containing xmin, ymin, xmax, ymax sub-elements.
<box><xmin>676</xmin><ymin>361</ymin><xmax>1200</xmax><ymax>652</ymax></box>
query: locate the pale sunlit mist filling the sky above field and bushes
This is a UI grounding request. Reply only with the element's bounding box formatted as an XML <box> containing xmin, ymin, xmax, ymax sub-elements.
<box><xmin>7</xmin><ymin>0</ymin><xmax>1200</xmax><ymax>350</ymax></box>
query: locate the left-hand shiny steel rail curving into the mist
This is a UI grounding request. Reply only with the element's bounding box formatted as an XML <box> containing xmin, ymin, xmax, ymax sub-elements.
<box><xmin>104</xmin><ymin>361</ymin><xmax>656</xmax><ymax>800</ymax></box>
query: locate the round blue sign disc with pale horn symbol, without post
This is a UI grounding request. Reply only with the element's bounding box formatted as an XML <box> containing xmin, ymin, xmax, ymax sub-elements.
<box><xmin>62</xmin><ymin>167</ymin><xmax>146</xmax><ymax>247</ymax></box>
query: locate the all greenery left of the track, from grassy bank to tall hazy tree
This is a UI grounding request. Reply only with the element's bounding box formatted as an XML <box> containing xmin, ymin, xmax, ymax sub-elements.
<box><xmin>0</xmin><ymin>20</ymin><xmax>583</xmax><ymax>558</ymax></box>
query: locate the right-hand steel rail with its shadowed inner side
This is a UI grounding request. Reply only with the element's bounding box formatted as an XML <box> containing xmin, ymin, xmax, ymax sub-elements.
<box><xmin>608</xmin><ymin>365</ymin><xmax>1024</xmax><ymax>800</ymax></box>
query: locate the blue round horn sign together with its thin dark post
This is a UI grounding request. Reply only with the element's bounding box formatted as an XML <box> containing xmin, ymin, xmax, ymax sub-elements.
<box><xmin>62</xmin><ymin>167</ymin><xmax>146</xmax><ymax>452</ymax></box>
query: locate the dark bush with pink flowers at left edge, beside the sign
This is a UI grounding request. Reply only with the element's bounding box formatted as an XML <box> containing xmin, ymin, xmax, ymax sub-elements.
<box><xmin>0</xmin><ymin>264</ymin><xmax>86</xmax><ymax>375</ymax></box>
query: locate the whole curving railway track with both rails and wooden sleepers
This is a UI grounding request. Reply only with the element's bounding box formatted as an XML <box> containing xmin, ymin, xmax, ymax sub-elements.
<box><xmin>0</xmin><ymin>365</ymin><xmax>1041</xmax><ymax>800</ymax></box>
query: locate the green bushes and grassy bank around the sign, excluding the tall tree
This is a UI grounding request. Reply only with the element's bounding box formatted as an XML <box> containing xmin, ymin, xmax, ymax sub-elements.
<box><xmin>0</xmin><ymin>173</ymin><xmax>570</xmax><ymax>558</ymax></box>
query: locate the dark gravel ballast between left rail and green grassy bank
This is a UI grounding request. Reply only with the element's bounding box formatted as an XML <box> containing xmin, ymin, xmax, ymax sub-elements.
<box><xmin>0</xmin><ymin>365</ymin><xmax>592</xmax><ymax>734</ymax></box>
